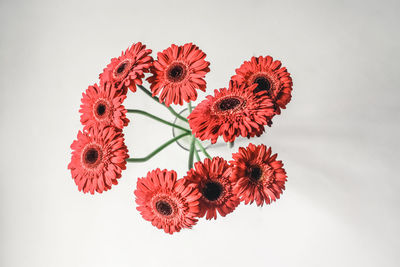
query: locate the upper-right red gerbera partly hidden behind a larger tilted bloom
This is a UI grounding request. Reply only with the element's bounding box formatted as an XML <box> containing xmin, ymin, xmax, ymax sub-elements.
<box><xmin>232</xmin><ymin>56</ymin><xmax>293</xmax><ymax>114</ymax></box>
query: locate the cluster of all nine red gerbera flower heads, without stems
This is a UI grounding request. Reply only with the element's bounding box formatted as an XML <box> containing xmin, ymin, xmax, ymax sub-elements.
<box><xmin>68</xmin><ymin>43</ymin><xmax>292</xmax><ymax>234</ymax></box>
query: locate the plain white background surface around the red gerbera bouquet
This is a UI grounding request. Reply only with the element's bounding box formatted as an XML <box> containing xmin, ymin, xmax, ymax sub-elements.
<box><xmin>0</xmin><ymin>0</ymin><xmax>400</xmax><ymax>267</ymax></box>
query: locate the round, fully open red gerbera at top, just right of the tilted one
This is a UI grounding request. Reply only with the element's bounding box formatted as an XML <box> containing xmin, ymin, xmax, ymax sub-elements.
<box><xmin>147</xmin><ymin>43</ymin><xmax>210</xmax><ymax>106</ymax></box>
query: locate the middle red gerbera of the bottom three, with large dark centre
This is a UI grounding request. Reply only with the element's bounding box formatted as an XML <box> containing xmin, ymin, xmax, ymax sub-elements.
<box><xmin>184</xmin><ymin>157</ymin><xmax>240</xmax><ymax>220</ymax></box>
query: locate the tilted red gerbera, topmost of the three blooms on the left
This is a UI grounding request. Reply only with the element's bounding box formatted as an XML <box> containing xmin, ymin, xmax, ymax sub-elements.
<box><xmin>100</xmin><ymin>42</ymin><xmax>153</xmax><ymax>94</ymax></box>
